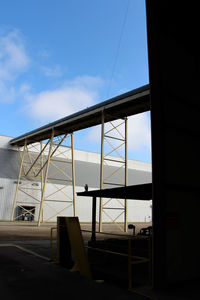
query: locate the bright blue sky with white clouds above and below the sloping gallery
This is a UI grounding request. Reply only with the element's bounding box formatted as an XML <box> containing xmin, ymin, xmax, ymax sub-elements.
<box><xmin>0</xmin><ymin>0</ymin><xmax>151</xmax><ymax>161</ymax></box>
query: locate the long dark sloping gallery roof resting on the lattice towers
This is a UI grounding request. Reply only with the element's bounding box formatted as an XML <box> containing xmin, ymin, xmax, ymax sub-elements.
<box><xmin>10</xmin><ymin>85</ymin><xmax>150</xmax><ymax>146</ymax></box>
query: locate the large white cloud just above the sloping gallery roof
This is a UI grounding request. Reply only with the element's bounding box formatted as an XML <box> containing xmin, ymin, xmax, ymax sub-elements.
<box><xmin>26</xmin><ymin>76</ymin><xmax>101</xmax><ymax>124</ymax></box>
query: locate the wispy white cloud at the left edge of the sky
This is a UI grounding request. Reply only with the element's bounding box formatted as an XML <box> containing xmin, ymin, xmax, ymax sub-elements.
<box><xmin>0</xmin><ymin>29</ymin><xmax>29</xmax><ymax>102</ymax></box>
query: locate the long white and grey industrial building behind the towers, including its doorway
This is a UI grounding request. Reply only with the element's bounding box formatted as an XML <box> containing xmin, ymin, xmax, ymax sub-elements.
<box><xmin>0</xmin><ymin>136</ymin><xmax>152</xmax><ymax>222</ymax></box>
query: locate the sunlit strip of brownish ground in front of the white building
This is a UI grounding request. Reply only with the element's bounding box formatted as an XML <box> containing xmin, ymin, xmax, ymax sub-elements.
<box><xmin>0</xmin><ymin>222</ymin><xmax>150</xmax><ymax>259</ymax></box>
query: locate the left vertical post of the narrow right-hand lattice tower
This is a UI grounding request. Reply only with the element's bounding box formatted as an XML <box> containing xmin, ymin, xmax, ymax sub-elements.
<box><xmin>99</xmin><ymin>111</ymin><xmax>105</xmax><ymax>232</ymax></box>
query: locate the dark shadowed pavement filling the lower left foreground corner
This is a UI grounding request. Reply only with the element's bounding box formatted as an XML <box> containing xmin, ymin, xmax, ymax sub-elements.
<box><xmin>0</xmin><ymin>246</ymin><xmax>146</xmax><ymax>300</ymax></box>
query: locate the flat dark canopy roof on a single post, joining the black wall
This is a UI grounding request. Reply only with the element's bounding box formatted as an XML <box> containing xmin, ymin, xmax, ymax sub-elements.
<box><xmin>77</xmin><ymin>183</ymin><xmax>152</xmax><ymax>200</ymax></box>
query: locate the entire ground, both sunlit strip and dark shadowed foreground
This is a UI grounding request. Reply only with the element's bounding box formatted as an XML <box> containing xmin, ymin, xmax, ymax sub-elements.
<box><xmin>0</xmin><ymin>222</ymin><xmax>152</xmax><ymax>300</ymax></box>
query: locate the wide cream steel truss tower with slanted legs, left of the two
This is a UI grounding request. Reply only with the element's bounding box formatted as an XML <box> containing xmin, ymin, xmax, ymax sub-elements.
<box><xmin>11</xmin><ymin>130</ymin><xmax>76</xmax><ymax>226</ymax></box>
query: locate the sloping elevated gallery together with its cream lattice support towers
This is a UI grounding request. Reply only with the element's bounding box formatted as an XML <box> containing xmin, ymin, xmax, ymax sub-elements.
<box><xmin>10</xmin><ymin>85</ymin><xmax>150</xmax><ymax>227</ymax></box>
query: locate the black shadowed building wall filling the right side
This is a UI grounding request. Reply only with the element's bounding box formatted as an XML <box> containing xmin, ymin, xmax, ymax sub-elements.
<box><xmin>1</xmin><ymin>0</ymin><xmax>200</xmax><ymax>299</ymax></box>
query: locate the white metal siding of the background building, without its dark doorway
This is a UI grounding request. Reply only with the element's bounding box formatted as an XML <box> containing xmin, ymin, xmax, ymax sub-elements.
<box><xmin>0</xmin><ymin>136</ymin><xmax>151</xmax><ymax>222</ymax></box>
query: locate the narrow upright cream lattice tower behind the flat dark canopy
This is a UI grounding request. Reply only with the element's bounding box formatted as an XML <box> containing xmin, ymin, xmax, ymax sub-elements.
<box><xmin>99</xmin><ymin>112</ymin><xmax>128</xmax><ymax>232</ymax></box>
